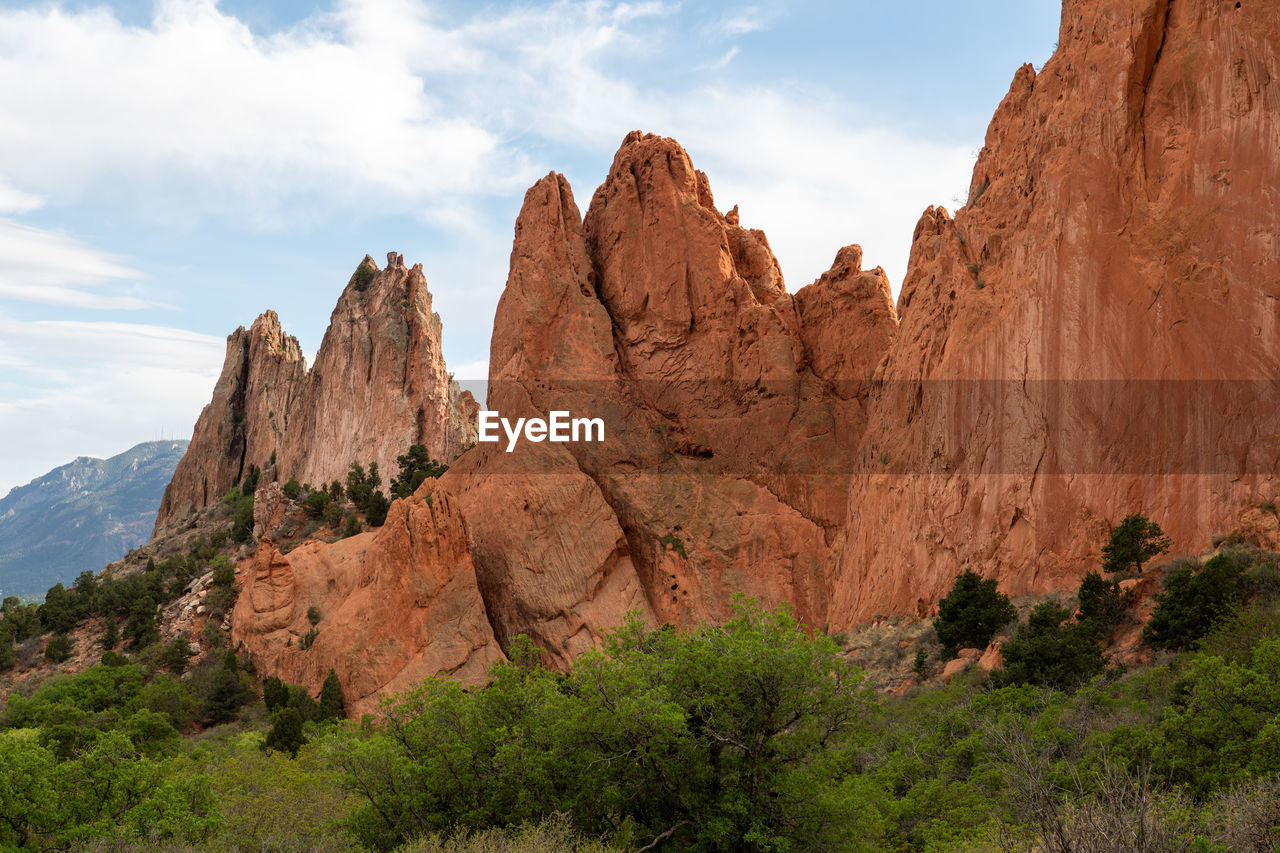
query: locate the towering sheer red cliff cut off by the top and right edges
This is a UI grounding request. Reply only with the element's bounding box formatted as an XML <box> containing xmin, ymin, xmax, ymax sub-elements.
<box><xmin>829</xmin><ymin>0</ymin><xmax>1280</xmax><ymax>625</ymax></box>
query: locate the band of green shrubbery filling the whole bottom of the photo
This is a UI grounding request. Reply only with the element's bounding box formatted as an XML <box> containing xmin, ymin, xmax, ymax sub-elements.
<box><xmin>0</xmin><ymin>591</ymin><xmax>1280</xmax><ymax>852</ymax></box>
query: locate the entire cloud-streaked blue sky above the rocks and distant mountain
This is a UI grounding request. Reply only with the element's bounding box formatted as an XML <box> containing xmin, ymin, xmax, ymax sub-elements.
<box><xmin>0</xmin><ymin>0</ymin><xmax>1060</xmax><ymax>494</ymax></box>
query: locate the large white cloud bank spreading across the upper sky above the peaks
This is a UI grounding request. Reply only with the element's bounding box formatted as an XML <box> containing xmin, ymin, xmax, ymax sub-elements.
<box><xmin>0</xmin><ymin>0</ymin><xmax>966</xmax><ymax>285</ymax></box>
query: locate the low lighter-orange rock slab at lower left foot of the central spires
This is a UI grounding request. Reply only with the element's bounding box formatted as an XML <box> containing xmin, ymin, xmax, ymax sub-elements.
<box><xmin>232</xmin><ymin>493</ymin><xmax>502</xmax><ymax>717</ymax></box>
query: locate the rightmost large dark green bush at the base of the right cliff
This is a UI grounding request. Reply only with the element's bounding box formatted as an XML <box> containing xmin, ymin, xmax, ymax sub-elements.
<box><xmin>1142</xmin><ymin>551</ymin><xmax>1249</xmax><ymax>649</ymax></box>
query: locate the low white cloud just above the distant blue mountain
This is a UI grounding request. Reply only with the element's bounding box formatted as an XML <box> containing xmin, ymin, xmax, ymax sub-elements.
<box><xmin>0</xmin><ymin>316</ymin><xmax>225</xmax><ymax>496</ymax></box>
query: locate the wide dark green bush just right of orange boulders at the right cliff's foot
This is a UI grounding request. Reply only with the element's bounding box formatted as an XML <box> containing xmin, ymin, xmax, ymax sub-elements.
<box><xmin>992</xmin><ymin>601</ymin><xmax>1106</xmax><ymax>690</ymax></box>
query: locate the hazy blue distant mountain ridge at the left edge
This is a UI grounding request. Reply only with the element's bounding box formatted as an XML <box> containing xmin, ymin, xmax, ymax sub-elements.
<box><xmin>0</xmin><ymin>441</ymin><xmax>187</xmax><ymax>596</ymax></box>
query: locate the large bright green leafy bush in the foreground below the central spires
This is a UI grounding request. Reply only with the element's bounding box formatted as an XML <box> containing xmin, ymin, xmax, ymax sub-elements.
<box><xmin>333</xmin><ymin>596</ymin><xmax>874</xmax><ymax>850</ymax></box>
